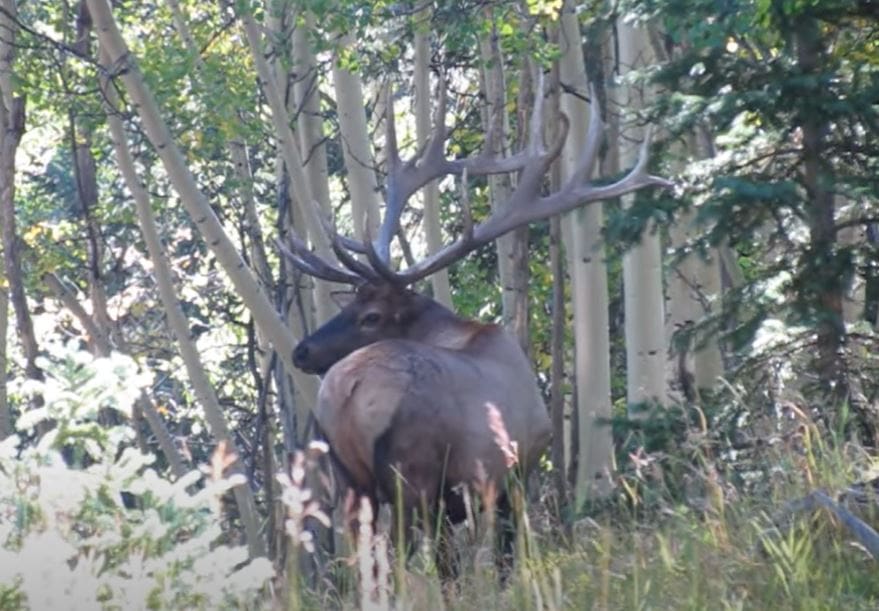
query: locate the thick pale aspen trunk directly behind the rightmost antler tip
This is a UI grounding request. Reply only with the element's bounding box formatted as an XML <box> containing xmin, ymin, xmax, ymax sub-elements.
<box><xmin>617</xmin><ymin>21</ymin><xmax>667</xmax><ymax>416</ymax></box>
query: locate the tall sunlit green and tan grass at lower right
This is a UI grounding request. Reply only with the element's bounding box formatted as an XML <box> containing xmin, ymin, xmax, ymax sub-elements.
<box><xmin>298</xmin><ymin>414</ymin><xmax>879</xmax><ymax>611</ymax></box>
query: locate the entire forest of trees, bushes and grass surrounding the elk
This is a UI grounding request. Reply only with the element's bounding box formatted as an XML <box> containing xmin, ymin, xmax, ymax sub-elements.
<box><xmin>0</xmin><ymin>0</ymin><xmax>879</xmax><ymax>608</ymax></box>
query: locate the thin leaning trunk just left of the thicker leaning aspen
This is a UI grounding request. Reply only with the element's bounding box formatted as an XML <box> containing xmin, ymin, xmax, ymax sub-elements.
<box><xmin>102</xmin><ymin>62</ymin><xmax>265</xmax><ymax>557</ymax></box>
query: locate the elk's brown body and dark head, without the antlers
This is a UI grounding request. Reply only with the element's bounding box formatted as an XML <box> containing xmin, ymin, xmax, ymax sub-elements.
<box><xmin>294</xmin><ymin>283</ymin><xmax>551</xmax><ymax>552</ymax></box>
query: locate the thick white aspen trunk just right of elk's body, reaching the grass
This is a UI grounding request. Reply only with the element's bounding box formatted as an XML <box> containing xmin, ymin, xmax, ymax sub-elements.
<box><xmin>559</xmin><ymin>2</ymin><xmax>613</xmax><ymax>507</ymax></box>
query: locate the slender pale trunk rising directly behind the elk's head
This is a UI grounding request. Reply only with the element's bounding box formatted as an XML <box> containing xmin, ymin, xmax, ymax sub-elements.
<box><xmin>414</xmin><ymin>5</ymin><xmax>454</xmax><ymax>308</ymax></box>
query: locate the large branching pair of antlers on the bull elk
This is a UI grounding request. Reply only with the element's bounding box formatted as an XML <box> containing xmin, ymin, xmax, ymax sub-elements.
<box><xmin>288</xmin><ymin>72</ymin><xmax>672</xmax><ymax>286</ymax></box>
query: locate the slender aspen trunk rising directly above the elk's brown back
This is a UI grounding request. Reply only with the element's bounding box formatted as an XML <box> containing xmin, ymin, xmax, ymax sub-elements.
<box><xmin>480</xmin><ymin>19</ymin><xmax>528</xmax><ymax>354</ymax></box>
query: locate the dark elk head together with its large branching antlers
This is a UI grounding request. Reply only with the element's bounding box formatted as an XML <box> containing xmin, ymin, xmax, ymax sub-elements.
<box><xmin>278</xmin><ymin>73</ymin><xmax>671</xmax><ymax>374</ymax></box>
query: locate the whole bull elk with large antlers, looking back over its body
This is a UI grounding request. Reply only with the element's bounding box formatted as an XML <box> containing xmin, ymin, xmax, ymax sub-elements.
<box><xmin>279</xmin><ymin>71</ymin><xmax>668</xmax><ymax>572</ymax></box>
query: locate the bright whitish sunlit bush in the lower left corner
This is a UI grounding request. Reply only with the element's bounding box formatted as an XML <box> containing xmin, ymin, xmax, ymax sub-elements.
<box><xmin>0</xmin><ymin>345</ymin><xmax>272</xmax><ymax>609</ymax></box>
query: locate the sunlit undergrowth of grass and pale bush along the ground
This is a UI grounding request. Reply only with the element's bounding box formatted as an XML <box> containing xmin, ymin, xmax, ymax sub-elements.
<box><xmin>0</xmin><ymin>346</ymin><xmax>879</xmax><ymax>611</ymax></box>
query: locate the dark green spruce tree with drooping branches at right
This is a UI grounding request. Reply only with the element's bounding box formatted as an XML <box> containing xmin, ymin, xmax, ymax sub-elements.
<box><xmin>607</xmin><ymin>0</ymin><xmax>879</xmax><ymax>443</ymax></box>
